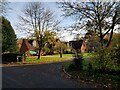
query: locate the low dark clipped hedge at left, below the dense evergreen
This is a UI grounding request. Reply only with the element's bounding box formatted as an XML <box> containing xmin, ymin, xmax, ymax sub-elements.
<box><xmin>2</xmin><ymin>53</ymin><xmax>22</xmax><ymax>63</ymax></box>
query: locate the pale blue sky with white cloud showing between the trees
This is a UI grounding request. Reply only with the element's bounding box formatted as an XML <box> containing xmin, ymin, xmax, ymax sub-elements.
<box><xmin>6</xmin><ymin>0</ymin><xmax>74</xmax><ymax>41</ymax></box>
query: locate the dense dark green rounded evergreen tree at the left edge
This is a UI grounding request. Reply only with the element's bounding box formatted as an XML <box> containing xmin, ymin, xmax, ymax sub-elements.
<box><xmin>1</xmin><ymin>17</ymin><xmax>17</xmax><ymax>53</ymax></box>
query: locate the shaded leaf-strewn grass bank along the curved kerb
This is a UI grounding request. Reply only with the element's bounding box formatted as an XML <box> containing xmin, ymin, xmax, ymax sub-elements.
<box><xmin>64</xmin><ymin>53</ymin><xmax>120</xmax><ymax>89</ymax></box>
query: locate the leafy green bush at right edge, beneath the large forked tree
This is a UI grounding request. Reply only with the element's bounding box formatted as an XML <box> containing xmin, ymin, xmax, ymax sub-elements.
<box><xmin>94</xmin><ymin>48</ymin><xmax>120</xmax><ymax>70</ymax></box>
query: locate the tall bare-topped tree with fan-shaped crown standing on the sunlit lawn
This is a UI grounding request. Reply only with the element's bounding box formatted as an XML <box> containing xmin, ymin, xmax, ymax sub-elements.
<box><xmin>19</xmin><ymin>2</ymin><xmax>58</xmax><ymax>59</ymax></box>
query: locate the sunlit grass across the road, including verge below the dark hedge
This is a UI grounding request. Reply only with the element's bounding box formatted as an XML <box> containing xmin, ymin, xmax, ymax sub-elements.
<box><xmin>3</xmin><ymin>54</ymin><xmax>73</xmax><ymax>64</ymax></box>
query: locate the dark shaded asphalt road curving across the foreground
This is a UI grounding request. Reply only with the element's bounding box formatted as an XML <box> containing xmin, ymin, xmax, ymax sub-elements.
<box><xmin>2</xmin><ymin>62</ymin><xmax>93</xmax><ymax>88</ymax></box>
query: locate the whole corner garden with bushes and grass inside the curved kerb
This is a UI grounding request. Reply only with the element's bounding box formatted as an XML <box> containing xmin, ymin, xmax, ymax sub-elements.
<box><xmin>64</xmin><ymin>49</ymin><xmax>120</xmax><ymax>89</ymax></box>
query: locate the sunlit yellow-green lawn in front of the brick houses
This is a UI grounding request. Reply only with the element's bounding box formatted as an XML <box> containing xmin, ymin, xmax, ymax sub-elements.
<box><xmin>22</xmin><ymin>53</ymin><xmax>91</xmax><ymax>64</ymax></box>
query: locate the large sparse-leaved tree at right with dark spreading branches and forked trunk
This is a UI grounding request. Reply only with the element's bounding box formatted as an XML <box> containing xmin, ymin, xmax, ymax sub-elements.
<box><xmin>60</xmin><ymin>1</ymin><xmax>120</xmax><ymax>47</ymax></box>
